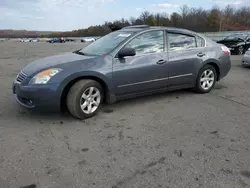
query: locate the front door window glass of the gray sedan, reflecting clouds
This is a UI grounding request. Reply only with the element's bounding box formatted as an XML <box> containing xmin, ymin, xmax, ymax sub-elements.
<box><xmin>125</xmin><ymin>31</ymin><xmax>164</xmax><ymax>55</ymax></box>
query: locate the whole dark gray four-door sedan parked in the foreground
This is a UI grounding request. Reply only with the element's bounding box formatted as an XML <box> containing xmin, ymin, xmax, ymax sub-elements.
<box><xmin>13</xmin><ymin>25</ymin><xmax>231</xmax><ymax>119</ymax></box>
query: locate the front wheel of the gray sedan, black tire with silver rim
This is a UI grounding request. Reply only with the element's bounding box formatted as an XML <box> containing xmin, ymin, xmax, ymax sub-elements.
<box><xmin>67</xmin><ymin>79</ymin><xmax>103</xmax><ymax>119</ymax></box>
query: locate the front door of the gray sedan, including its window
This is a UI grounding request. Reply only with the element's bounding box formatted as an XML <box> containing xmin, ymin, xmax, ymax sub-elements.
<box><xmin>113</xmin><ymin>30</ymin><xmax>168</xmax><ymax>95</ymax></box>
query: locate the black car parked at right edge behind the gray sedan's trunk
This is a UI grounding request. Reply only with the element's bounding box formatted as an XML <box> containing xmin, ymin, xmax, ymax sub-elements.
<box><xmin>217</xmin><ymin>34</ymin><xmax>250</xmax><ymax>55</ymax></box>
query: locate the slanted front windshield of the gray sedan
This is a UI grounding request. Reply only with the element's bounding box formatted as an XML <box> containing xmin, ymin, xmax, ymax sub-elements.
<box><xmin>79</xmin><ymin>31</ymin><xmax>133</xmax><ymax>55</ymax></box>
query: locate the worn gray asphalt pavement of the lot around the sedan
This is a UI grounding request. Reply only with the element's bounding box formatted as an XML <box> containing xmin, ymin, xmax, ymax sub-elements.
<box><xmin>0</xmin><ymin>41</ymin><xmax>250</xmax><ymax>188</ymax></box>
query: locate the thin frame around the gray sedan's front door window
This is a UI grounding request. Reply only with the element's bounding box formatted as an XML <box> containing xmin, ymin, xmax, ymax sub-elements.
<box><xmin>114</xmin><ymin>29</ymin><xmax>167</xmax><ymax>58</ymax></box>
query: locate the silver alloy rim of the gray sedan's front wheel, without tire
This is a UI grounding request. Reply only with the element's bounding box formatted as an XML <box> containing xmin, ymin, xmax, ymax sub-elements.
<box><xmin>80</xmin><ymin>87</ymin><xmax>101</xmax><ymax>114</ymax></box>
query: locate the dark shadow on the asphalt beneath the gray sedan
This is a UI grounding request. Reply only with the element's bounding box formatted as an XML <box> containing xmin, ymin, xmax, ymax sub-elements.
<box><xmin>11</xmin><ymin>83</ymin><xmax>226</xmax><ymax>123</ymax></box>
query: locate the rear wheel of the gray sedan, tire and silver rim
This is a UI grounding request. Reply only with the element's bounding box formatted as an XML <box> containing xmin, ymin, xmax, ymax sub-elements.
<box><xmin>194</xmin><ymin>65</ymin><xmax>217</xmax><ymax>93</ymax></box>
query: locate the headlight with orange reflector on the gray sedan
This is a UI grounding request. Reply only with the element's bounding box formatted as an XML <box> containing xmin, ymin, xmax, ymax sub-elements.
<box><xmin>29</xmin><ymin>68</ymin><xmax>62</xmax><ymax>85</ymax></box>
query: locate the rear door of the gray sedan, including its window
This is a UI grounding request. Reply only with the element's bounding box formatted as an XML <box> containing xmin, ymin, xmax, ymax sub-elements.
<box><xmin>167</xmin><ymin>32</ymin><xmax>206</xmax><ymax>87</ymax></box>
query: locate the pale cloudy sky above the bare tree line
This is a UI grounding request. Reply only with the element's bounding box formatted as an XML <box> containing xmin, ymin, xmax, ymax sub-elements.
<box><xmin>0</xmin><ymin>0</ymin><xmax>247</xmax><ymax>31</ymax></box>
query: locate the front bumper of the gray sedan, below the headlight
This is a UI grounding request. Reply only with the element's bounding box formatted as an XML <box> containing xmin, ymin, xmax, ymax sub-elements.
<box><xmin>12</xmin><ymin>82</ymin><xmax>60</xmax><ymax>111</ymax></box>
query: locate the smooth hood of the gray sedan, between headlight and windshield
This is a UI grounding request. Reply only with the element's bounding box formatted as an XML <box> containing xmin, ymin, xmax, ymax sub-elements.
<box><xmin>22</xmin><ymin>52</ymin><xmax>96</xmax><ymax>76</ymax></box>
